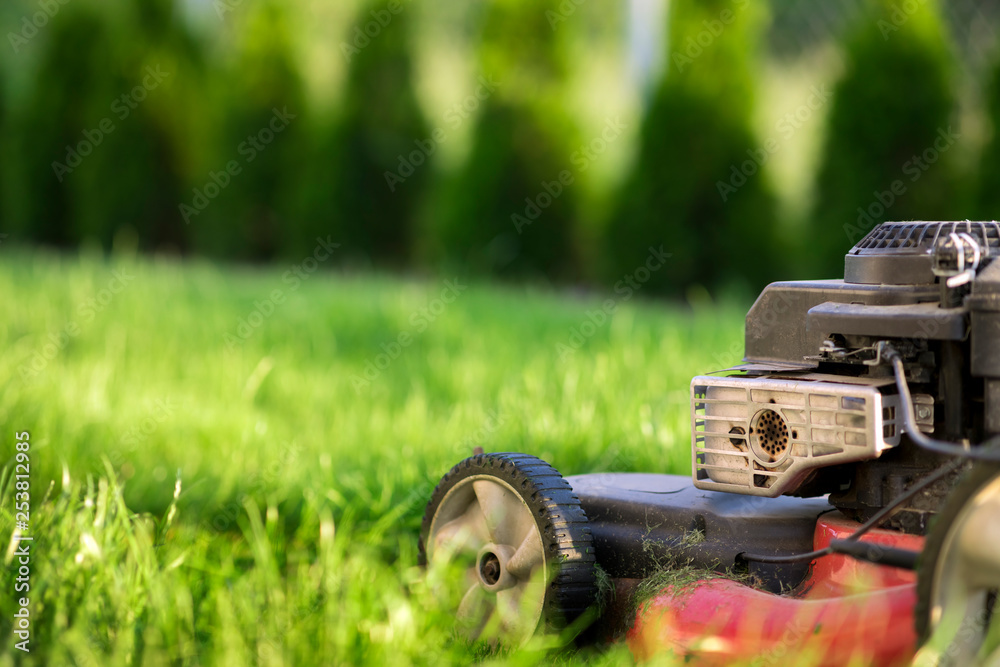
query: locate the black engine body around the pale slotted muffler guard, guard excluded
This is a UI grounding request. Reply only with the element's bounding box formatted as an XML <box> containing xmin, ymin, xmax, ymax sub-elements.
<box><xmin>695</xmin><ymin>221</ymin><xmax>1000</xmax><ymax>533</ymax></box>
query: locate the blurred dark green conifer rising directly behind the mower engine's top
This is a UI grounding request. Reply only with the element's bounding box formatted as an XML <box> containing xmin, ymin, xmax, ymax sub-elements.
<box><xmin>802</xmin><ymin>0</ymin><xmax>966</xmax><ymax>277</ymax></box>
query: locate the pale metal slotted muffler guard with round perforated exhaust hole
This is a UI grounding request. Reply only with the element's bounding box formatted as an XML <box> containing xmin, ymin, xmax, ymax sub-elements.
<box><xmin>691</xmin><ymin>375</ymin><xmax>902</xmax><ymax>497</ymax></box>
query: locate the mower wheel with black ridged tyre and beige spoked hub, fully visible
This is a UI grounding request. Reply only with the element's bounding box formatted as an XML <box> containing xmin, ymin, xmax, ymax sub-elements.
<box><xmin>420</xmin><ymin>454</ymin><xmax>596</xmax><ymax>646</ymax></box>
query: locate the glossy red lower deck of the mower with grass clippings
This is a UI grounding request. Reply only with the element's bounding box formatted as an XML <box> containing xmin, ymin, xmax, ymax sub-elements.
<box><xmin>627</xmin><ymin>513</ymin><xmax>924</xmax><ymax>667</ymax></box>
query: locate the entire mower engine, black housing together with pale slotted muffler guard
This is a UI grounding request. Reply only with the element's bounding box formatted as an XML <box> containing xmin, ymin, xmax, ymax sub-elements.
<box><xmin>691</xmin><ymin>222</ymin><xmax>1000</xmax><ymax>533</ymax></box>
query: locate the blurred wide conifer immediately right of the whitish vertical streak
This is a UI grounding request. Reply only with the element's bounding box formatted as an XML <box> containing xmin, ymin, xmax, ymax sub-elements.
<box><xmin>605</xmin><ymin>0</ymin><xmax>777</xmax><ymax>294</ymax></box>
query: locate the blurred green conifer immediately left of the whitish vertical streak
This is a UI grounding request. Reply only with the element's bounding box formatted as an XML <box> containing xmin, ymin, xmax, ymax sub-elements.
<box><xmin>432</xmin><ymin>0</ymin><xmax>579</xmax><ymax>278</ymax></box>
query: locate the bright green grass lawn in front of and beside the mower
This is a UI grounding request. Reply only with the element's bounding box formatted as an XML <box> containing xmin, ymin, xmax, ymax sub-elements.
<box><xmin>0</xmin><ymin>252</ymin><xmax>747</xmax><ymax>665</ymax></box>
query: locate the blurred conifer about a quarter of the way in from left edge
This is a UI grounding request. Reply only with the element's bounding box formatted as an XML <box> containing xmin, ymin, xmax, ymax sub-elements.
<box><xmin>190</xmin><ymin>0</ymin><xmax>309</xmax><ymax>260</ymax></box>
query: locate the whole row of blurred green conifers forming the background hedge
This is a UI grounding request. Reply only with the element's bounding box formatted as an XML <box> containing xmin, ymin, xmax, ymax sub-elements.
<box><xmin>0</xmin><ymin>0</ymin><xmax>984</xmax><ymax>294</ymax></box>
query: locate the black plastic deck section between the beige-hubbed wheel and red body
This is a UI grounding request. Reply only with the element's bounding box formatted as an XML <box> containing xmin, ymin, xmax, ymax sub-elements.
<box><xmin>566</xmin><ymin>473</ymin><xmax>835</xmax><ymax>592</ymax></box>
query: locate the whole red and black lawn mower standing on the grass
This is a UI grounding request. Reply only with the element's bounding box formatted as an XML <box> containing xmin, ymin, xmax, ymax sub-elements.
<box><xmin>420</xmin><ymin>221</ymin><xmax>1000</xmax><ymax>665</ymax></box>
